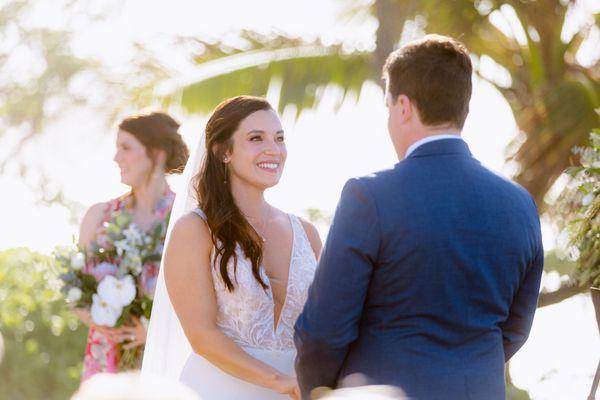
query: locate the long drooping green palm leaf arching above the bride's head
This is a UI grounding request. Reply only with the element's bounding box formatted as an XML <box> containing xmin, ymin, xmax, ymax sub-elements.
<box><xmin>164</xmin><ymin>47</ymin><xmax>372</xmax><ymax>115</ymax></box>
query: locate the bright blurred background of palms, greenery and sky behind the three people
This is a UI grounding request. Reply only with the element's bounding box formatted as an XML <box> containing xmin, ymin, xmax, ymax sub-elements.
<box><xmin>0</xmin><ymin>0</ymin><xmax>600</xmax><ymax>400</ymax></box>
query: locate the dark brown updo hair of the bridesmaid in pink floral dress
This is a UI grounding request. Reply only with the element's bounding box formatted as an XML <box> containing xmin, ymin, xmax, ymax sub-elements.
<box><xmin>119</xmin><ymin>111</ymin><xmax>189</xmax><ymax>174</ymax></box>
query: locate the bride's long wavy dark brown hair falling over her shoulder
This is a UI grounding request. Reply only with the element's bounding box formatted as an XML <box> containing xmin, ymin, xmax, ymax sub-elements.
<box><xmin>194</xmin><ymin>96</ymin><xmax>273</xmax><ymax>292</ymax></box>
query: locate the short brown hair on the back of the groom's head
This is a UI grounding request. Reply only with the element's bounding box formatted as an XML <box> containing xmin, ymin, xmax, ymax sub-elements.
<box><xmin>383</xmin><ymin>35</ymin><xmax>473</xmax><ymax>129</ymax></box>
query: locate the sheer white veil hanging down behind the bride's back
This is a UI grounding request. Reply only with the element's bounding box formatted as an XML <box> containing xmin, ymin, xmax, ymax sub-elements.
<box><xmin>142</xmin><ymin>134</ymin><xmax>205</xmax><ymax>380</ymax></box>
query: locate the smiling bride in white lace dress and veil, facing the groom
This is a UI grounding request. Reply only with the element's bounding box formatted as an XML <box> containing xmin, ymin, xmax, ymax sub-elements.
<box><xmin>142</xmin><ymin>96</ymin><xmax>321</xmax><ymax>400</ymax></box>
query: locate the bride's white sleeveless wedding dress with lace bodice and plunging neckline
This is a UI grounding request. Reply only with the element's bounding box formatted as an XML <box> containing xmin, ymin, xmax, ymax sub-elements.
<box><xmin>180</xmin><ymin>209</ymin><xmax>317</xmax><ymax>400</ymax></box>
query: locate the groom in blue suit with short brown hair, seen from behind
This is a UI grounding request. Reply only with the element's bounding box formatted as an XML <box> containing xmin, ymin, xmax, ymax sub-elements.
<box><xmin>295</xmin><ymin>35</ymin><xmax>544</xmax><ymax>400</ymax></box>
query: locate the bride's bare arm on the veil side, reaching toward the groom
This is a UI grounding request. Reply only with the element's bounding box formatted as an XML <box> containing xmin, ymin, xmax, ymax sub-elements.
<box><xmin>164</xmin><ymin>213</ymin><xmax>296</xmax><ymax>393</ymax></box>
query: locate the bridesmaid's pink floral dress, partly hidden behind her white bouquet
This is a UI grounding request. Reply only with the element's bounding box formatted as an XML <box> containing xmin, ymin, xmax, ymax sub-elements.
<box><xmin>82</xmin><ymin>189</ymin><xmax>175</xmax><ymax>380</ymax></box>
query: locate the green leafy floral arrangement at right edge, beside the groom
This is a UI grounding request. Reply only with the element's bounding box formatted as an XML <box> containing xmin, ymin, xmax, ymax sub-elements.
<box><xmin>553</xmin><ymin>129</ymin><xmax>600</xmax><ymax>286</ymax></box>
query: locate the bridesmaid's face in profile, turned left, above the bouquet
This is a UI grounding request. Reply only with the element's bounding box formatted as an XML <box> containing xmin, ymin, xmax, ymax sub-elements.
<box><xmin>114</xmin><ymin>130</ymin><xmax>152</xmax><ymax>188</ymax></box>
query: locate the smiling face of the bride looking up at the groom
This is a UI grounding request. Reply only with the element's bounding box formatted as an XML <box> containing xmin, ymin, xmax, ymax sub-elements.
<box><xmin>225</xmin><ymin>110</ymin><xmax>287</xmax><ymax>189</ymax></box>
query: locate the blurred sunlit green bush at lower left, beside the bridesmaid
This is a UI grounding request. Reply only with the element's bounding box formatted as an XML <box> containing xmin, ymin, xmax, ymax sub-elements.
<box><xmin>0</xmin><ymin>249</ymin><xmax>87</xmax><ymax>400</ymax></box>
